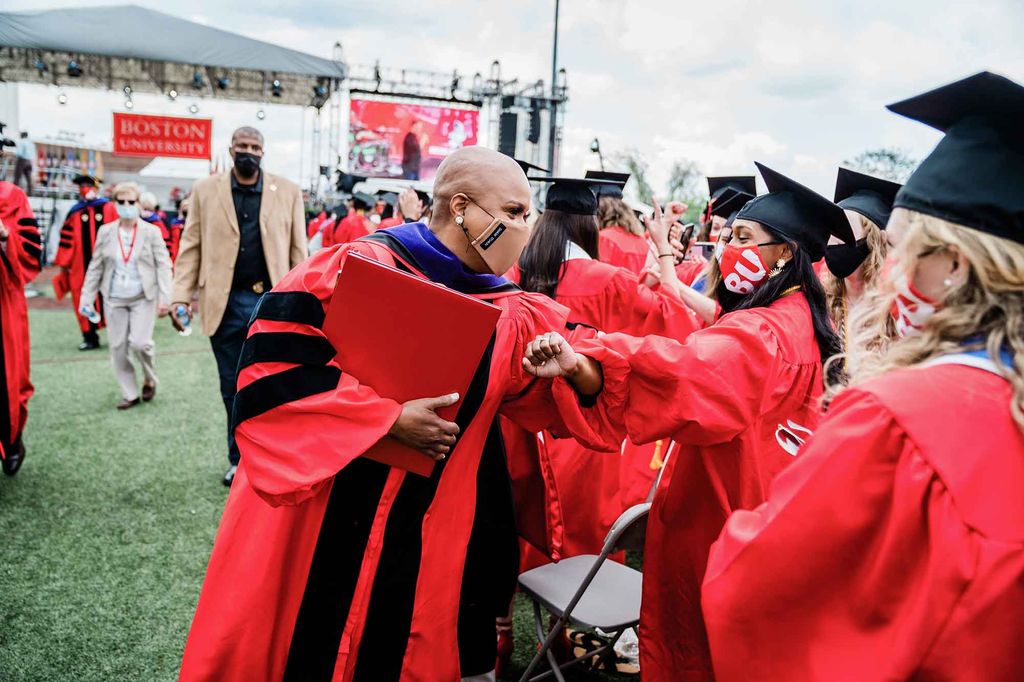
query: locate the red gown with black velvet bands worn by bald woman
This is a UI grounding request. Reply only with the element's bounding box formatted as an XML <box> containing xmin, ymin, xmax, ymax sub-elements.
<box><xmin>181</xmin><ymin>232</ymin><xmax>565</xmax><ymax>682</ymax></box>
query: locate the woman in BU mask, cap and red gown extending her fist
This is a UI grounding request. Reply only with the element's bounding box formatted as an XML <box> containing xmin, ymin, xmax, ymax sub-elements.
<box><xmin>524</xmin><ymin>165</ymin><xmax>853</xmax><ymax>682</ymax></box>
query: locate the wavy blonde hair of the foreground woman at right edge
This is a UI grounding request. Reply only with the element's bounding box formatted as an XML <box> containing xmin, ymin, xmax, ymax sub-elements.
<box><xmin>846</xmin><ymin>209</ymin><xmax>1024</xmax><ymax>431</ymax></box>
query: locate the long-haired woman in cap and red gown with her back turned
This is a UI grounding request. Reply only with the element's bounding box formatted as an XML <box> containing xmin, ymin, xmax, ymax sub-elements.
<box><xmin>505</xmin><ymin>180</ymin><xmax>701</xmax><ymax>570</ymax></box>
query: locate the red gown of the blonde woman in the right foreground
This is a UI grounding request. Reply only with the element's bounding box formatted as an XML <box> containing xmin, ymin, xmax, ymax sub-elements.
<box><xmin>703</xmin><ymin>366</ymin><xmax>1024</xmax><ymax>682</ymax></box>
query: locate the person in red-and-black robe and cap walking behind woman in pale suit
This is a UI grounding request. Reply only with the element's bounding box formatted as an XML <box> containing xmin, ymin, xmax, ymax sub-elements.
<box><xmin>53</xmin><ymin>175</ymin><xmax>118</xmax><ymax>350</ymax></box>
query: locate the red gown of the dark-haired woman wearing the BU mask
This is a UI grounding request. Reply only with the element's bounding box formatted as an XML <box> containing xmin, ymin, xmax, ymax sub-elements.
<box><xmin>554</xmin><ymin>293</ymin><xmax>822</xmax><ymax>682</ymax></box>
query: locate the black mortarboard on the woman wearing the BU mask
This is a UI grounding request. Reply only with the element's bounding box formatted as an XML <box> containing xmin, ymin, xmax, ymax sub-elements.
<box><xmin>736</xmin><ymin>162</ymin><xmax>855</xmax><ymax>261</ymax></box>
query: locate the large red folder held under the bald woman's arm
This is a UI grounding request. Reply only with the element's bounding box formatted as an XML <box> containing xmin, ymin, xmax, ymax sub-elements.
<box><xmin>324</xmin><ymin>248</ymin><xmax>501</xmax><ymax>476</ymax></box>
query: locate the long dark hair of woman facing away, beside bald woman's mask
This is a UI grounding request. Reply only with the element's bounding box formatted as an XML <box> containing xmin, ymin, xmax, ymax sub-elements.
<box><xmin>519</xmin><ymin>209</ymin><xmax>597</xmax><ymax>298</ymax></box>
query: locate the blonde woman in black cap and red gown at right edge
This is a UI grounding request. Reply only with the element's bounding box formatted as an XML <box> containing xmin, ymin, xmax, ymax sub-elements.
<box><xmin>703</xmin><ymin>74</ymin><xmax>1024</xmax><ymax>682</ymax></box>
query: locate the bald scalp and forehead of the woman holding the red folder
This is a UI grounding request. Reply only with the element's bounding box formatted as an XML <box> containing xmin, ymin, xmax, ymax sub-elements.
<box><xmin>434</xmin><ymin>146</ymin><xmax>530</xmax><ymax>221</ymax></box>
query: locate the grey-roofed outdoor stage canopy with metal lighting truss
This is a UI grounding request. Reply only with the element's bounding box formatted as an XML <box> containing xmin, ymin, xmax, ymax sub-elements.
<box><xmin>0</xmin><ymin>5</ymin><xmax>567</xmax><ymax>196</ymax></box>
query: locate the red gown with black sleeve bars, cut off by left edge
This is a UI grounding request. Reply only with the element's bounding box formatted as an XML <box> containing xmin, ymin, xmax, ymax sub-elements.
<box><xmin>0</xmin><ymin>181</ymin><xmax>41</xmax><ymax>456</ymax></box>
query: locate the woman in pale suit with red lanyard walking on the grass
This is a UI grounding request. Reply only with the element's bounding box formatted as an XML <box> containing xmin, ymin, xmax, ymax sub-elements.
<box><xmin>81</xmin><ymin>182</ymin><xmax>171</xmax><ymax>410</ymax></box>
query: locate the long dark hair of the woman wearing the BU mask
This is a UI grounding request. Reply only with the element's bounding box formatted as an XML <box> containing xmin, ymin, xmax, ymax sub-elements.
<box><xmin>708</xmin><ymin>225</ymin><xmax>843</xmax><ymax>380</ymax></box>
